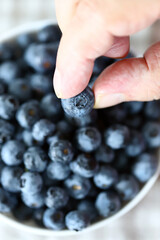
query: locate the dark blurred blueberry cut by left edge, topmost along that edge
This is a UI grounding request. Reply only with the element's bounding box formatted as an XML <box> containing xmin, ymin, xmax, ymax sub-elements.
<box><xmin>0</xmin><ymin>43</ymin><xmax>14</xmax><ymax>62</ymax></box>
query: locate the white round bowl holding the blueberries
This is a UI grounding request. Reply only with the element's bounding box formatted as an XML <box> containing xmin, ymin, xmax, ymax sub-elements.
<box><xmin>0</xmin><ymin>20</ymin><xmax>160</xmax><ymax>240</ymax></box>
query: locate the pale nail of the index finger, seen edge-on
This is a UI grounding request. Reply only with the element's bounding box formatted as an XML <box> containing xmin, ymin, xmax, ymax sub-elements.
<box><xmin>53</xmin><ymin>68</ymin><xmax>62</xmax><ymax>98</ymax></box>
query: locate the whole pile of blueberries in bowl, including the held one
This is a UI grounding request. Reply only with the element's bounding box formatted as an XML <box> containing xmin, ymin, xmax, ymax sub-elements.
<box><xmin>0</xmin><ymin>25</ymin><xmax>160</xmax><ymax>231</ymax></box>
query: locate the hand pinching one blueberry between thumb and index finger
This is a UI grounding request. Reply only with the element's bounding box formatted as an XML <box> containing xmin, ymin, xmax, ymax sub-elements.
<box><xmin>54</xmin><ymin>0</ymin><xmax>160</xmax><ymax>108</ymax></box>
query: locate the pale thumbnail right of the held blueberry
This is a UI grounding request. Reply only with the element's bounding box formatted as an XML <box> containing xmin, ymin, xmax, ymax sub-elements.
<box><xmin>94</xmin><ymin>93</ymin><xmax>126</xmax><ymax>108</ymax></box>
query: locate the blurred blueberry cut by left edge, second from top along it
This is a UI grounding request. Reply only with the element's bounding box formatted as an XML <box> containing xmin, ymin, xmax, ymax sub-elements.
<box><xmin>0</xmin><ymin>61</ymin><xmax>21</xmax><ymax>84</ymax></box>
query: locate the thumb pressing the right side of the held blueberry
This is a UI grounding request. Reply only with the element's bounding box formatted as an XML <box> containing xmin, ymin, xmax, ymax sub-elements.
<box><xmin>93</xmin><ymin>42</ymin><xmax>160</xmax><ymax>108</ymax></box>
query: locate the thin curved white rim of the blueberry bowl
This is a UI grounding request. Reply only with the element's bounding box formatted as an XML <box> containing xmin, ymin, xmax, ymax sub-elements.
<box><xmin>0</xmin><ymin>19</ymin><xmax>160</xmax><ymax>237</ymax></box>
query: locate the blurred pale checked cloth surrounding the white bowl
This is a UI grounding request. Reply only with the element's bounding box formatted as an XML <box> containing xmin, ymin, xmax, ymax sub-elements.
<box><xmin>0</xmin><ymin>0</ymin><xmax>160</xmax><ymax>240</ymax></box>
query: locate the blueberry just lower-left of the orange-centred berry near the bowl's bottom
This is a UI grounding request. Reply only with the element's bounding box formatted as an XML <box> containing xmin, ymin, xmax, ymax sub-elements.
<box><xmin>45</xmin><ymin>187</ymin><xmax>69</xmax><ymax>209</ymax></box>
